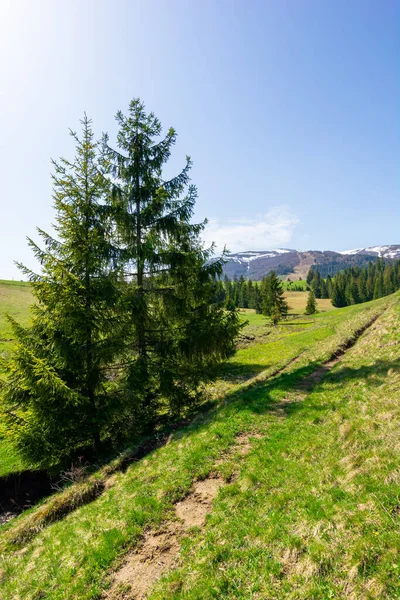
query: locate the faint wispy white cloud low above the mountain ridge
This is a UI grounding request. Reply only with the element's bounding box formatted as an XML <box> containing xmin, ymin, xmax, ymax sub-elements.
<box><xmin>202</xmin><ymin>206</ymin><xmax>299</xmax><ymax>252</ymax></box>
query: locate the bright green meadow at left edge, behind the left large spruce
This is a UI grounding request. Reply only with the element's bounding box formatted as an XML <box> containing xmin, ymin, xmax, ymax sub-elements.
<box><xmin>0</xmin><ymin>281</ymin><xmax>32</xmax><ymax>477</ymax></box>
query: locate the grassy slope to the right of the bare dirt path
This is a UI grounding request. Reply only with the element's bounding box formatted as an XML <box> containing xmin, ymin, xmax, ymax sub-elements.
<box><xmin>152</xmin><ymin>304</ymin><xmax>400</xmax><ymax>600</ymax></box>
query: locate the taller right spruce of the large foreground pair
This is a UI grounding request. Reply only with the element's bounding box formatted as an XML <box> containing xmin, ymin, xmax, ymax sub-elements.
<box><xmin>103</xmin><ymin>99</ymin><xmax>240</xmax><ymax>428</ymax></box>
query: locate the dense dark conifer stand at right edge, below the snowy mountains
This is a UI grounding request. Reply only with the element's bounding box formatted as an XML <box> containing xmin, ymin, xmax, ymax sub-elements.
<box><xmin>307</xmin><ymin>258</ymin><xmax>400</xmax><ymax>307</ymax></box>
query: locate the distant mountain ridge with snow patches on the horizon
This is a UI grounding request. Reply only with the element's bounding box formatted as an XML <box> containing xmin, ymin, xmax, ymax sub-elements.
<box><xmin>224</xmin><ymin>244</ymin><xmax>400</xmax><ymax>281</ymax></box>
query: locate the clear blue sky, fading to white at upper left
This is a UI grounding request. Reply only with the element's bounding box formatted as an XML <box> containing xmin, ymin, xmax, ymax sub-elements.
<box><xmin>0</xmin><ymin>0</ymin><xmax>400</xmax><ymax>278</ymax></box>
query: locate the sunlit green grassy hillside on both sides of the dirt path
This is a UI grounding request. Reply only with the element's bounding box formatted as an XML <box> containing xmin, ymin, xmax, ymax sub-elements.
<box><xmin>0</xmin><ymin>297</ymin><xmax>400</xmax><ymax>600</ymax></box>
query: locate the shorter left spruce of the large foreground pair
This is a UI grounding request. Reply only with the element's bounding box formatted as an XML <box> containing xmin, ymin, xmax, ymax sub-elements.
<box><xmin>2</xmin><ymin>116</ymin><xmax>121</xmax><ymax>467</ymax></box>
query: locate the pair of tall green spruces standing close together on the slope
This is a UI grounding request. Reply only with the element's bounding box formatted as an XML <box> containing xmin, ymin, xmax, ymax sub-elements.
<box><xmin>0</xmin><ymin>99</ymin><xmax>241</xmax><ymax>468</ymax></box>
